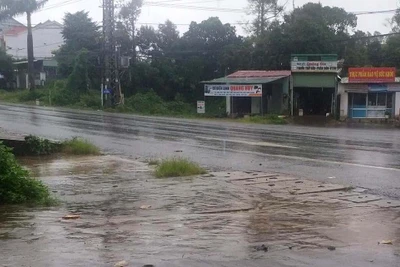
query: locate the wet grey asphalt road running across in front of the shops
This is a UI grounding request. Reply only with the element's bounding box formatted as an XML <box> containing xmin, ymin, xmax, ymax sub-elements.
<box><xmin>0</xmin><ymin>104</ymin><xmax>400</xmax><ymax>198</ymax></box>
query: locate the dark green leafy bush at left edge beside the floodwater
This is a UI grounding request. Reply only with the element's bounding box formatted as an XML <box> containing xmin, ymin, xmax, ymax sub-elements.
<box><xmin>0</xmin><ymin>143</ymin><xmax>56</xmax><ymax>205</ymax></box>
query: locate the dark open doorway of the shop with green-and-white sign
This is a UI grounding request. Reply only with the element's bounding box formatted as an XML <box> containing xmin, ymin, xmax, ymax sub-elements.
<box><xmin>294</xmin><ymin>88</ymin><xmax>335</xmax><ymax>116</ymax></box>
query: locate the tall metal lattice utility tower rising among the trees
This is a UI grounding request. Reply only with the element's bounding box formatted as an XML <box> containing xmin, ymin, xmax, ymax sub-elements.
<box><xmin>103</xmin><ymin>0</ymin><xmax>121</xmax><ymax>105</ymax></box>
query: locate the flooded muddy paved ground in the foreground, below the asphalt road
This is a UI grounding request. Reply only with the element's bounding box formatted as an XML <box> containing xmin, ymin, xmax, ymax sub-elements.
<box><xmin>0</xmin><ymin>156</ymin><xmax>400</xmax><ymax>267</ymax></box>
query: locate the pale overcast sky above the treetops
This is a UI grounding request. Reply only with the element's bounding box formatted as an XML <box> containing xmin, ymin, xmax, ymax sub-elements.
<box><xmin>18</xmin><ymin>0</ymin><xmax>400</xmax><ymax>34</ymax></box>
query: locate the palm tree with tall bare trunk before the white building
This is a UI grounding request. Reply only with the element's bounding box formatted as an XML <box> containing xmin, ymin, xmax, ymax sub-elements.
<box><xmin>0</xmin><ymin>0</ymin><xmax>48</xmax><ymax>90</ymax></box>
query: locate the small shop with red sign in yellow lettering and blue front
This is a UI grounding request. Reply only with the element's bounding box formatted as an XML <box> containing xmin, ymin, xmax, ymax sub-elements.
<box><xmin>338</xmin><ymin>68</ymin><xmax>400</xmax><ymax>120</ymax></box>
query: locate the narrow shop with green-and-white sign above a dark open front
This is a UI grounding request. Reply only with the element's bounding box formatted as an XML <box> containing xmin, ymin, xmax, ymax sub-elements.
<box><xmin>290</xmin><ymin>54</ymin><xmax>340</xmax><ymax>116</ymax></box>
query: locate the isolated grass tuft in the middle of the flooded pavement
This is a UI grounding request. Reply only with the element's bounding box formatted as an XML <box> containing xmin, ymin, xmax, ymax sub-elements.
<box><xmin>155</xmin><ymin>158</ymin><xmax>207</xmax><ymax>178</ymax></box>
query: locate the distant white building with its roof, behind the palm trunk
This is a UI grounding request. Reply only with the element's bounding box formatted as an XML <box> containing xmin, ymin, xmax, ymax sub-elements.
<box><xmin>0</xmin><ymin>19</ymin><xmax>64</xmax><ymax>59</ymax></box>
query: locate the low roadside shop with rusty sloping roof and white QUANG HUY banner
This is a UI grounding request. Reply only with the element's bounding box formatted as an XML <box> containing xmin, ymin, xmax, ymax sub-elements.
<box><xmin>203</xmin><ymin>70</ymin><xmax>291</xmax><ymax>116</ymax></box>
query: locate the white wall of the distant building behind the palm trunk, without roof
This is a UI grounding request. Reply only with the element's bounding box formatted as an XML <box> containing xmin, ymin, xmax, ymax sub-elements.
<box><xmin>4</xmin><ymin>28</ymin><xmax>63</xmax><ymax>59</ymax></box>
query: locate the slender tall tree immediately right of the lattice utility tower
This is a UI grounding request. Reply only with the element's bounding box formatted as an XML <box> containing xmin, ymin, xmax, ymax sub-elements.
<box><xmin>118</xmin><ymin>0</ymin><xmax>143</xmax><ymax>62</ymax></box>
